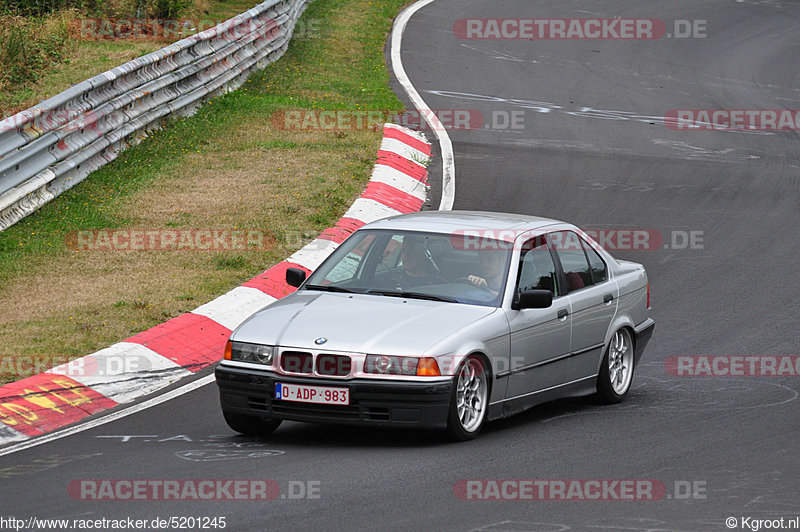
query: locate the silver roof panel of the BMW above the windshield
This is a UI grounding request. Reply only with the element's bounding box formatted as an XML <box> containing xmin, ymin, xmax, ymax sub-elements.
<box><xmin>363</xmin><ymin>211</ymin><xmax>566</xmax><ymax>240</ymax></box>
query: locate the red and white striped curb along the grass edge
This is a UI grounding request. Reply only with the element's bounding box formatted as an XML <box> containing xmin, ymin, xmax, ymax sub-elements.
<box><xmin>0</xmin><ymin>124</ymin><xmax>431</xmax><ymax>445</ymax></box>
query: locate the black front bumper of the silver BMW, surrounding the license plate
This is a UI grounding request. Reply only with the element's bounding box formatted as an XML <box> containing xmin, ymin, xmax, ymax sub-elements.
<box><xmin>214</xmin><ymin>365</ymin><xmax>453</xmax><ymax>429</ymax></box>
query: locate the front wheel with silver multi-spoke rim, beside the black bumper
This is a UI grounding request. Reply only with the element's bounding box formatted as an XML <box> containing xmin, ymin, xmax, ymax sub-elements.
<box><xmin>447</xmin><ymin>356</ymin><xmax>489</xmax><ymax>441</ymax></box>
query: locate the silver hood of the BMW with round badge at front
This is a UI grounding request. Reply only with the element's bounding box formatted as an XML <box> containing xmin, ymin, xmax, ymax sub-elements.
<box><xmin>231</xmin><ymin>290</ymin><xmax>498</xmax><ymax>355</ymax></box>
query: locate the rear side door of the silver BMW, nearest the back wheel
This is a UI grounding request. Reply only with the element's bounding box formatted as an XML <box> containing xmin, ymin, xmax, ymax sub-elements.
<box><xmin>549</xmin><ymin>231</ymin><xmax>619</xmax><ymax>382</ymax></box>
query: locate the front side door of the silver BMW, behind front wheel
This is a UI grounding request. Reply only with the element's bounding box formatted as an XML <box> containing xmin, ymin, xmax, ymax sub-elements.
<box><xmin>506</xmin><ymin>235</ymin><xmax>571</xmax><ymax>399</ymax></box>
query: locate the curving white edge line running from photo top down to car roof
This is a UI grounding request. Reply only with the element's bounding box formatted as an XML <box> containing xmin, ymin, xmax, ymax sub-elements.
<box><xmin>392</xmin><ymin>0</ymin><xmax>456</xmax><ymax>211</ymax></box>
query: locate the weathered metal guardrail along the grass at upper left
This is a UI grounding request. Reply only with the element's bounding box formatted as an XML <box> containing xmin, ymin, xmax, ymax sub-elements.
<box><xmin>0</xmin><ymin>0</ymin><xmax>310</xmax><ymax>231</ymax></box>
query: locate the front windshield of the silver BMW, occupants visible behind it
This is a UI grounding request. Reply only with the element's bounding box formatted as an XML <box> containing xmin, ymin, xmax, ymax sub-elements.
<box><xmin>304</xmin><ymin>230</ymin><xmax>512</xmax><ymax>307</ymax></box>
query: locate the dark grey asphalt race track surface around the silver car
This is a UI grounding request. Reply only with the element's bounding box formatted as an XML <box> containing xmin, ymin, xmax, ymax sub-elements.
<box><xmin>0</xmin><ymin>0</ymin><xmax>800</xmax><ymax>531</ymax></box>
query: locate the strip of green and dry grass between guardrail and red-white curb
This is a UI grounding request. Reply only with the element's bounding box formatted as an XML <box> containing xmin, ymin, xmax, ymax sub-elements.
<box><xmin>0</xmin><ymin>0</ymin><xmax>404</xmax><ymax>382</ymax></box>
